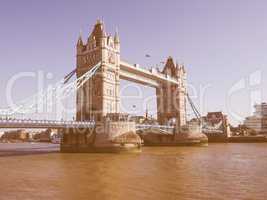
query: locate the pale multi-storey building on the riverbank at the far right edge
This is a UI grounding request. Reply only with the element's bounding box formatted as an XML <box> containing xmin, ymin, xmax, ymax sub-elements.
<box><xmin>244</xmin><ymin>103</ymin><xmax>267</xmax><ymax>134</ymax></box>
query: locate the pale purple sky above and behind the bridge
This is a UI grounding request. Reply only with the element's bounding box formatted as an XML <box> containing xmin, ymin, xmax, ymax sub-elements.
<box><xmin>0</xmin><ymin>0</ymin><xmax>267</xmax><ymax>124</ymax></box>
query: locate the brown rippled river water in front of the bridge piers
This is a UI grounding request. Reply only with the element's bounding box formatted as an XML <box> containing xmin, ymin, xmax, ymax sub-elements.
<box><xmin>0</xmin><ymin>143</ymin><xmax>267</xmax><ymax>200</ymax></box>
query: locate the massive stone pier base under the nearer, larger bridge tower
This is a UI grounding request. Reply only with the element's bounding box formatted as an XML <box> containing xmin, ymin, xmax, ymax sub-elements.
<box><xmin>60</xmin><ymin>115</ymin><xmax>141</xmax><ymax>153</ymax></box>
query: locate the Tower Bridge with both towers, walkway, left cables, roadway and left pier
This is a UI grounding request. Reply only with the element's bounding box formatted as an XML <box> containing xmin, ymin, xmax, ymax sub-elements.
<box><xmin>0</xmin><ymin>20</ymin><xmax>207</xmax><ymax>152</ymax></box>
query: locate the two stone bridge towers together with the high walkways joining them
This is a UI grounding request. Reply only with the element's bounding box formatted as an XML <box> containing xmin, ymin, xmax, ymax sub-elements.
<box><xmin>76</xmin><ymin>20</ymin><xmax>186</xmax><ymax>126</ymax></box>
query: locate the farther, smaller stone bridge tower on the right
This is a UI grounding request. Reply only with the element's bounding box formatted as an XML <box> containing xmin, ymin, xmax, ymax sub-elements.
<box><xmin>156</xmin><ymin>57</ymin><xmax>186</xmax><ymax>126</ymax></box>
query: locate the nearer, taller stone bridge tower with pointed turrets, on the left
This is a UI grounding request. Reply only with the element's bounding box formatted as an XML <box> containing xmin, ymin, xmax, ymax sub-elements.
<box><xmin>76</xmin><ymin>20</ymin><xmax>120</xmax><ymax>121</ymax></box>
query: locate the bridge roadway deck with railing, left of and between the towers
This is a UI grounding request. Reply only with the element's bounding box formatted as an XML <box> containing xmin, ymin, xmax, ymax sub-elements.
<box><xmin>0</xmin><ymin>119</ymin><xmax>173</xmax><ymax>130</ymax></box>
